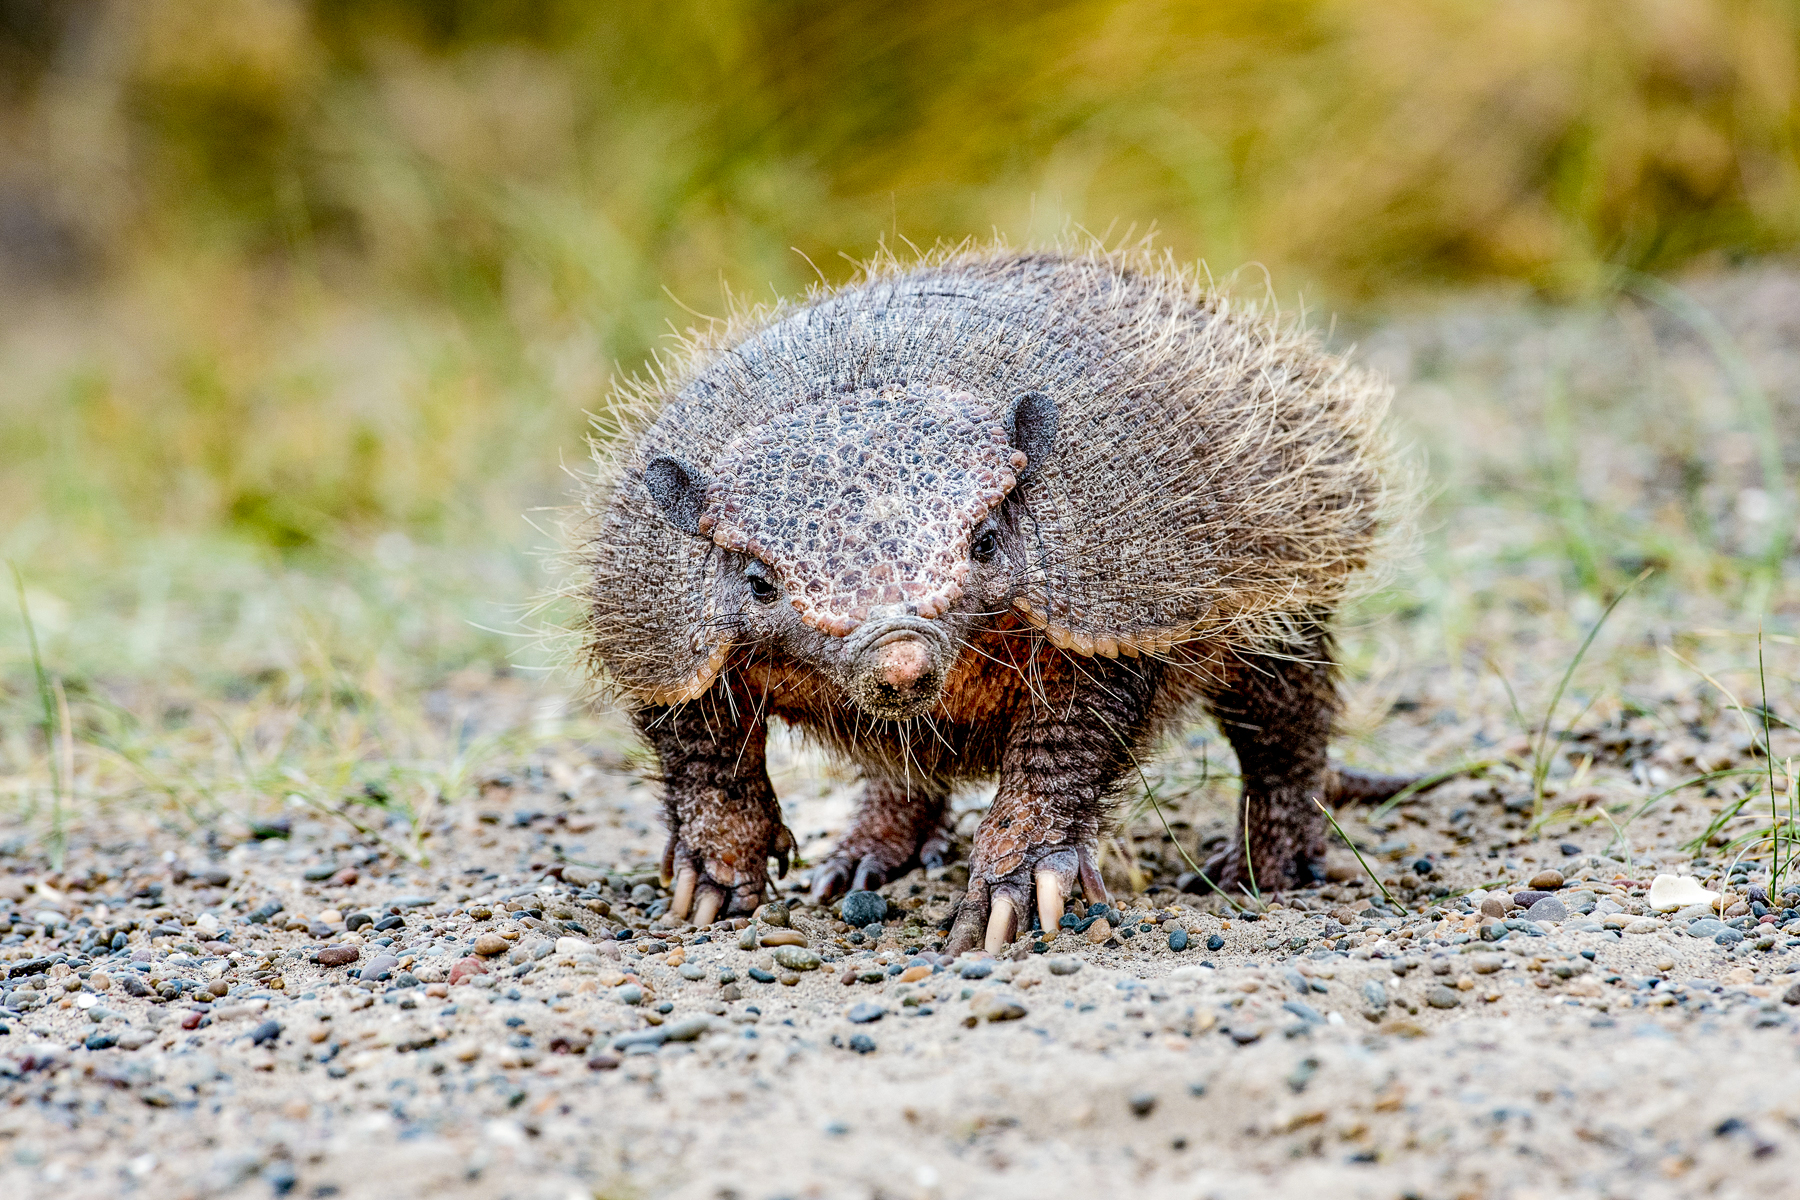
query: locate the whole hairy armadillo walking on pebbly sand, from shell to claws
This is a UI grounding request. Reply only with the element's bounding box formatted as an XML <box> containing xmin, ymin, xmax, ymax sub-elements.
<box><xmin>585</xmin><ymin>252</ymin><xmax>1406</xmax><ymax>952</ymax></box>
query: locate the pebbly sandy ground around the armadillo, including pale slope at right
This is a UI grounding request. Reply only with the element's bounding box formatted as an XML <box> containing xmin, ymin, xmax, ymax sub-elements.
<box><xmin>10</xmin><ymin>270</ymin><xmax>1800</xmax><ymax>1200</ymax></box>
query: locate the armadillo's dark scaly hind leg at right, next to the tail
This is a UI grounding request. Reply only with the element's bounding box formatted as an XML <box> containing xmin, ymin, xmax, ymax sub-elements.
<box><xmin>1190</xmin><ymin>622</ymin><xmax>1337</xmax><ymax>900</ymax></box>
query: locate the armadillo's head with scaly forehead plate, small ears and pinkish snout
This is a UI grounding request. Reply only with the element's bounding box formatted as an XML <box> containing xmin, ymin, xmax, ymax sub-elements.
<box><xmin>644</xmin><ymin>385</ymin><xmax>1057</xmax><ymax>720</ymax></box>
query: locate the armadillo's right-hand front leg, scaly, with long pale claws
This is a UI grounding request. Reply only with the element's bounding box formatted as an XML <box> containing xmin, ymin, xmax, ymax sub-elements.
<box><xmin>945</xmin><ymin>658</ymin><xmax>1163</xmax><ymax>954</ymax></box>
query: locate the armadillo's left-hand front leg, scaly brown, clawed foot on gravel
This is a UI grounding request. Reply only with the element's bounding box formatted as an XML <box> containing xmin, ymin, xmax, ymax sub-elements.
<box><xmin>634</xmin><ymin>700</ymin><xmax>794</xmax><ymax>925</ymax></box>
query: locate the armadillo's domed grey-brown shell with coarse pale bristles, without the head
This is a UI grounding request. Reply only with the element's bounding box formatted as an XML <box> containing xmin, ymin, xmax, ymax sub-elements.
<box><xmin>574</xmin><ymin>245</ymin><xmax>1409</xmax><ymax>707</ymax></box>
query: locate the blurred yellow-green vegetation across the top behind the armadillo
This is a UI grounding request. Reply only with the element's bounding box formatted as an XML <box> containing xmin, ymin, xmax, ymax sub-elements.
<box><xmin>10</xmin><ymin>0</ymin><xmax>1800</xmax><ymax>549</ymax></box>
